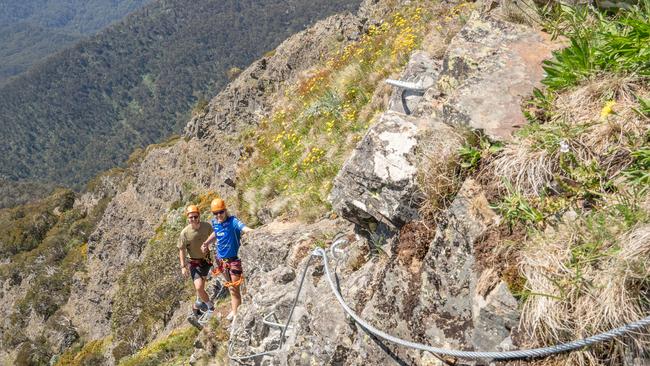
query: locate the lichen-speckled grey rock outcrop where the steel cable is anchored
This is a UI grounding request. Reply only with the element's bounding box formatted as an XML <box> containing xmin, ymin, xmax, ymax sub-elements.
<box><xmin>220</xmin><ymin>181</ymin><xmax>518</xmax><ymax>365</ymax></box>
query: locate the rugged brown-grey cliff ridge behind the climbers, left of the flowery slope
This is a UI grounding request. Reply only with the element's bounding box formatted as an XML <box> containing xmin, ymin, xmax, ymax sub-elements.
<box><xmin>68</xmin><ymin>10</ymin><xmax>370</xmax><ymax>344</ymax></box>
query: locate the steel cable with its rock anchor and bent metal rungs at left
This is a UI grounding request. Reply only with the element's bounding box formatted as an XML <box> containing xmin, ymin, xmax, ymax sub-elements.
<box><xmin>228</xmin><ymin>237</ymin><xmax>650</xmax><ymax>361</ymax></box>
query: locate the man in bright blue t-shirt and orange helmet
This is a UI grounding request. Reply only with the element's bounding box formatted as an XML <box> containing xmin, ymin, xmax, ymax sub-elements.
<box><xmin>202</xmin><ymin>198</ymin><xmax>253</xmax><ymax>320</ymax></box>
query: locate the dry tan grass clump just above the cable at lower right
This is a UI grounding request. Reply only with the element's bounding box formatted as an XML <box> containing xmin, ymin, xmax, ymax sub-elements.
<box><xmin>521</xmin><ymin>210</ymin><xmax>650</xmax><ymax>365</ymax></box>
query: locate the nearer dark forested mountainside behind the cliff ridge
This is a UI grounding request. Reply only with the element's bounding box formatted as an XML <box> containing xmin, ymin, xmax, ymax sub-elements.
<box><xmin>0</xmin><ymin>0</ymin><xmax>360</xmax><ymax>200</ymax></box>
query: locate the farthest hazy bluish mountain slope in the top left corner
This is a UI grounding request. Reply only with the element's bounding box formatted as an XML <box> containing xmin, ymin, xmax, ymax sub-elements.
<box><xmin>0</xmin><ymin>0</ymin><xmax>151</xmax><ymax>85</ymax></box>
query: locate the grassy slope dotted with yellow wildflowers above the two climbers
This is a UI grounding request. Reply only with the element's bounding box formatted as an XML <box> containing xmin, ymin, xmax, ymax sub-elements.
<box><xmin>237</xmin><ymin>1</ymin><xmax>467</xmax><ymax>222</ymax></box>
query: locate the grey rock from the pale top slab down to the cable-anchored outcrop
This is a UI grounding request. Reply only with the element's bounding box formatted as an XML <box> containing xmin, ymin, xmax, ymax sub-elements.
<box><xmin>196</xmin><ymin>10</ymin><xmax>556</xmax><ymax>365</ymax></box>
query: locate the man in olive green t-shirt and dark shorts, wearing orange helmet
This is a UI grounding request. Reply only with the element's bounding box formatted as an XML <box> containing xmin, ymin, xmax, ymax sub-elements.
<box><xmin>177</xmin><ymin>205</ymin><xmax>214</xmax><ymax>323</ymax></box>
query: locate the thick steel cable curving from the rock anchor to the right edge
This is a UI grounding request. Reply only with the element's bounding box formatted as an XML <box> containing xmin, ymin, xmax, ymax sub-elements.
<box><xmin>312</xmin><ymin>248</ymin><xmax>650</xmax><ymax>360</ymax></box>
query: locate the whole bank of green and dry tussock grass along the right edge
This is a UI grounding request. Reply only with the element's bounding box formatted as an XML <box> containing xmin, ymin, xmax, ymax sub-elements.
<box><xmin>470</xmin><ymin>1</ymin><xmax>650</xmax><ymax>365</ymax></box>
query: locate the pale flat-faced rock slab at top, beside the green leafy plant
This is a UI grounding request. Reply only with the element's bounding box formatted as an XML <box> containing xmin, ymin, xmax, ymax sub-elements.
<box><xmin>438</xmin><ymin>14</ymin><xmax>558</xmax><ymax>140</ymax></box>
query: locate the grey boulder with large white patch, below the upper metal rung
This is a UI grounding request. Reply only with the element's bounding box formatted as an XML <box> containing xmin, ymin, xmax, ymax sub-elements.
<box><xmin>329</xmin><ymin>112</ymin><xmax>427</xmax><ymax>232</ymax></box>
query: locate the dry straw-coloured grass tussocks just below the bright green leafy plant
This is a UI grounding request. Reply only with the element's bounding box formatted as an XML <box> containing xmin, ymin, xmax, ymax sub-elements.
<box><xmin>481</xmin><ymin>76</ymin><xmax>650</xmax><ymax>197</ymax></box>
